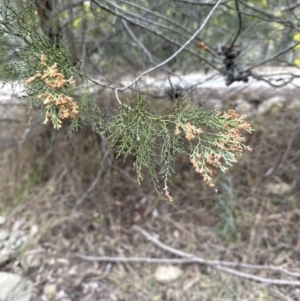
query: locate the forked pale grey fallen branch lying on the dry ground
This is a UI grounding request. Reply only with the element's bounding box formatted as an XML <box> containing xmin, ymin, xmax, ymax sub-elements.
<box><xmin>76</xmin><ymin>226</ymin><xmax>300</xmax><ymax>286</ymax></box>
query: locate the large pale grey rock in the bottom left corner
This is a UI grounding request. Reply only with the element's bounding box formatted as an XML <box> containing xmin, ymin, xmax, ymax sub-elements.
<box><xmin>0</xmin><ymin>272</ymin><xmax>33</xmax><ymax>301</ymax></box>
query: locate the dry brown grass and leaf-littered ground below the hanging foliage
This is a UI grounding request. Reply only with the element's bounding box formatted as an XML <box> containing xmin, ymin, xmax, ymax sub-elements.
<box><xmin>0</xmin><ymin>85</ymin><xmax>300</xmax><ymax>301</ymax></box>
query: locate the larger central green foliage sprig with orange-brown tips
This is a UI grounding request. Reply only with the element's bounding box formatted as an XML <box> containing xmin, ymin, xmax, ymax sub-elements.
<box><xmin>107</xmin><ymin>95</ymin><xmax>253</xmax><ymax>200</ymax></box>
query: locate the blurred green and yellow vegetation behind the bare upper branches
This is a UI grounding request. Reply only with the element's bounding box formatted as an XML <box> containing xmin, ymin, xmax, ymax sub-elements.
<box><xmin>0</xmin><ymin>0</ymin><xmax>299</xmax><ymax>80</ymax></box>
